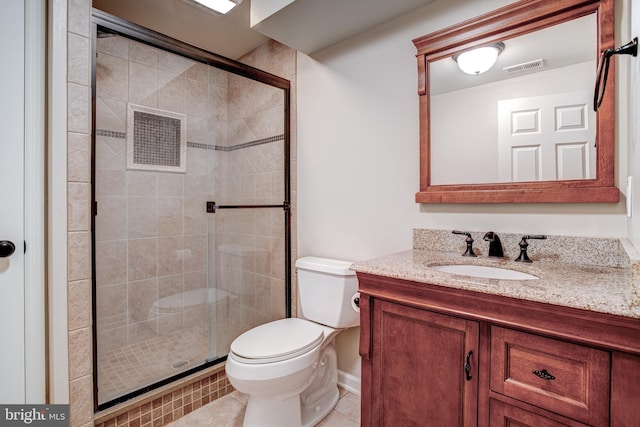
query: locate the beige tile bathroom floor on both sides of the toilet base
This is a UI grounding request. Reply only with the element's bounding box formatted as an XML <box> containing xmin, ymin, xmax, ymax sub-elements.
<box><xmin>166</xmin><ymin>389</ymin><xmax>360</xmax><ymax>427</ymax></box>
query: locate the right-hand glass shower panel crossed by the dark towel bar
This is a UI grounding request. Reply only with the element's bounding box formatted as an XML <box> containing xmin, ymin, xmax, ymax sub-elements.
<box><xmin>207</xmin><ymin>71</ymin><xmax>291</xmax><ymax>354</ymax></box>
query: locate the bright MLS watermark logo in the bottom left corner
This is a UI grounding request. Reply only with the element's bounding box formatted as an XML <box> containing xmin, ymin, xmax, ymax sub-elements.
<box><xmin>0</xmin><ymin>405</ymin><xmax>69</xmax><ymax>427</ymax></box>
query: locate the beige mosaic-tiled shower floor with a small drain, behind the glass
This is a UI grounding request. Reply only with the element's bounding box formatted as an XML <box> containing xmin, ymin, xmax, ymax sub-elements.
<box><xmin>98</xmin><ymin>326</ymin><xmax>209</xmax><ymax>403</ymax></box>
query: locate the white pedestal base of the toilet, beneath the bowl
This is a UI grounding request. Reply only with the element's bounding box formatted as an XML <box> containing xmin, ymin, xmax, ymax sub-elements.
<box><xmin>242</xmin><ymin>344</ymin><xmax>339</xmax><ymax>427</ymax></box>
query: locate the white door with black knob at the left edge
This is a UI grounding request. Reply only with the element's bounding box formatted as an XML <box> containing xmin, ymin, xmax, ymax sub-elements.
<box><xmin>0</xmin><ymin>0</ymin><xmax>25</xmax><ymax>404</ymax></box>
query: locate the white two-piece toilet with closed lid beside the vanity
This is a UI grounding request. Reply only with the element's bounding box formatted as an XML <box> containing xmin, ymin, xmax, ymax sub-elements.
<box><xmin>225</xmin><ymin>257</ymin><xmax>360</xmax><ymax>427</ymax></box>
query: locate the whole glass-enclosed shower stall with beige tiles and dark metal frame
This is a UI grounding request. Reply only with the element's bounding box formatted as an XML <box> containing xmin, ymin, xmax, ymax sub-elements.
<box><xmin>92</xmin><ymin>11</ymin><xmax>291</xmax><ymax>409</ymax></box>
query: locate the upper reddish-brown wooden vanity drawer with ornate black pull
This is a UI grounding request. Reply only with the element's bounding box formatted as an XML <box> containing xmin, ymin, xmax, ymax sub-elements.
<box><xmin>490</xmin><ymin>326</ymin><xmax>610</xmax><ymax>425</ymax></box>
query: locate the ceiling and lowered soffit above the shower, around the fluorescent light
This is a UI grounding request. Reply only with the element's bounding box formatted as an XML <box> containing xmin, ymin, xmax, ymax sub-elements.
<box><xmin>93</xmin><ymin>0</ymin><xmax>432</xmax><ymax>59</ymax></box>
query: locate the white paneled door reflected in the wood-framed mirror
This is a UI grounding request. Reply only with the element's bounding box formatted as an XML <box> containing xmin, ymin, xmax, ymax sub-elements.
<box><xmin>498</xmin><ymin>91</ymin><xmax>596</xmax><ymax>182</ymax></box>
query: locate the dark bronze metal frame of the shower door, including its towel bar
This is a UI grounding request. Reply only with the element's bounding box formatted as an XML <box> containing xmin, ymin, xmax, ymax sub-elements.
<box><xmin>91</xmin><ymin>9</ymin><xmax>292</xmax><ymax>411</ymax></box>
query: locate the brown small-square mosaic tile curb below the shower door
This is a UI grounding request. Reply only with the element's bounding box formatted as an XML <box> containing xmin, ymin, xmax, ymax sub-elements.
<box><xmin>94</xmin><ymin>365</ymin><xmax>234</xmax><ymax>427</ymax></box>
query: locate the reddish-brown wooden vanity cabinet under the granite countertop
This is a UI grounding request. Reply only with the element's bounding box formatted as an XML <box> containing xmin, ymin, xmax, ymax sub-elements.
<box><xmin>358</xmin><ymin>272</ymin><xmax>640</xmax><ymax>427</ymax></box>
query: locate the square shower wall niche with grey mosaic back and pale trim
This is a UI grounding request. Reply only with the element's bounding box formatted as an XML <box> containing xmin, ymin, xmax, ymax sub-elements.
<box><xmin>127</xmin><ymin>104</ymin><xmax>187</xmax><ymax>173</ymax></box>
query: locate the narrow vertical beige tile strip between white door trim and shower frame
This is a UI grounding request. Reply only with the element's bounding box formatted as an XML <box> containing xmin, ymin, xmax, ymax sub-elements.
<box><xmin>67</xmin><ymin>0</ymin><xmax>93</xmax><ymax>427</ymax></box>
